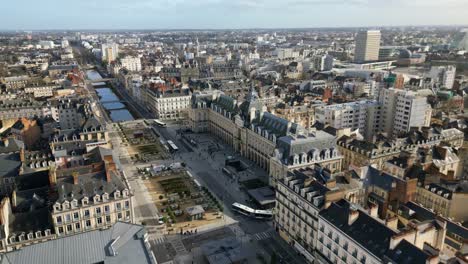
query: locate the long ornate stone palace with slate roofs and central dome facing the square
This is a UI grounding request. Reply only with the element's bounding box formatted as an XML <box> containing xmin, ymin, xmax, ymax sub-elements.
<box><xmin>189</xmin><ymin>90</ymin><xmax>342</xmax><ymax>186</ymax></box>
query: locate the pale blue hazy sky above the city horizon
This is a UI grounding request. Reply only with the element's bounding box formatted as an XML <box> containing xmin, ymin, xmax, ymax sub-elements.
<box><xmin>0</xmin><ymin>0</ymin><xmax>468</xmax><ymax>30</ymax></box>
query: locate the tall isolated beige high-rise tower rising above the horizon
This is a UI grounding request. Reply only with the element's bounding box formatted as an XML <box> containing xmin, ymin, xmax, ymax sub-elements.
<box><xmin>354</xmin><ymin>30</ymin><xmax>381</xmax><ymax>63</ymax></box>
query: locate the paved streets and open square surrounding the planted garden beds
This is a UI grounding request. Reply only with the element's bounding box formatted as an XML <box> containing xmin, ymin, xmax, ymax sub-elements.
<box><xmin>73</xmin><ymin>47</ymin><xmax>302</xmax><ymax>263</ymax></box>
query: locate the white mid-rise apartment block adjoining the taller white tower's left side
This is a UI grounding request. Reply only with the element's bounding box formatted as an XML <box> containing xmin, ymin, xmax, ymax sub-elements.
<box><xmin>315</xmin><ymin>100</ymin><xmax>381</xmax><ymax>139</ymax></box>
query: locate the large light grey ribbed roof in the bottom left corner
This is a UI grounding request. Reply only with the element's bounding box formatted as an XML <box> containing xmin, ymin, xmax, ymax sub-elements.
<box><xmin>0</xmin><ymin>222</ymin><xmax>153</xmax><ymax>264</ymax></box>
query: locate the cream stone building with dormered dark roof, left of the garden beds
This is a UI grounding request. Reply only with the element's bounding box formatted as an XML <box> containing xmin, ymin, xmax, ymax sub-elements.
<box><xmin>51</xmin><ymin>156</ymin><xmax>133</xmax><ymax>236</ymax></box>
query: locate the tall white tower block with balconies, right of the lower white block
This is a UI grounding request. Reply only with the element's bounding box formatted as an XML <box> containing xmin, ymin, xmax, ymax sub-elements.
<box><xmin>379</xmin><ymin>88</ymin><xmax>432</xmax><ymax>136</ymax></box>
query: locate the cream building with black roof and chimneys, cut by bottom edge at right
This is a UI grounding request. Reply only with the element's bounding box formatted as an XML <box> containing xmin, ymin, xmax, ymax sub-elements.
<box><xmin>316</xmin><ymin>200</ymin><xmax>439</xmax><ymax>264</ymax></box>
